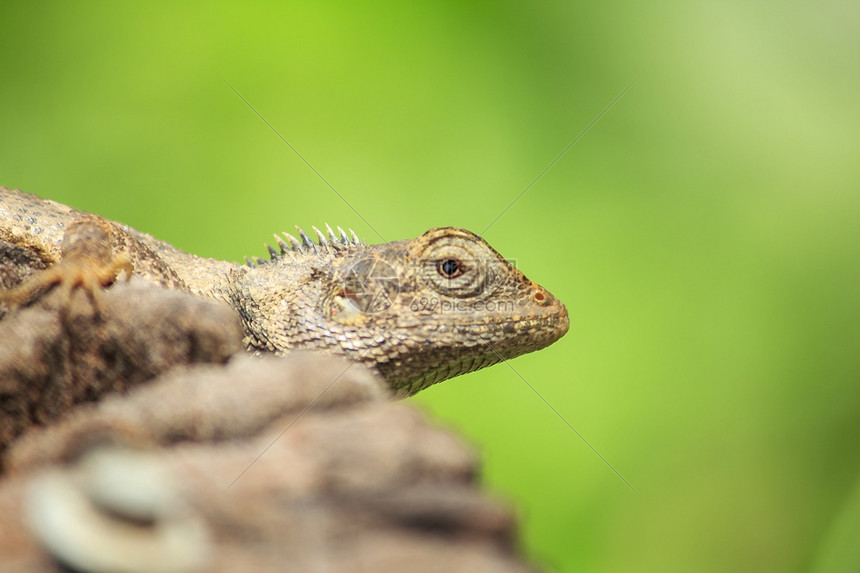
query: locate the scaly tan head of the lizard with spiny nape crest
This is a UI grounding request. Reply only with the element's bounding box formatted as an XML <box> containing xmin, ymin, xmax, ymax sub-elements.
<box><xmin>234</xmin><ymin>227</ymin><xmax>569</xmax><ymax>395</ymax></box>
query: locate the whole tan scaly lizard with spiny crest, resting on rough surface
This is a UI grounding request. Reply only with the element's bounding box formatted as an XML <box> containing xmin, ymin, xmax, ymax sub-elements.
<box><xmin>0</xmin><ymin>187</ymin><xmax>569</xmax><ymax>396</ymax></box>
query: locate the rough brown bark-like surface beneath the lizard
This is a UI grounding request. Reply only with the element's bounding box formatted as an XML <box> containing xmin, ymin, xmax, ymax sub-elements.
<box><xmin>0</xmin><ymin>284</ymin><xmax>531</xmax><ymax>572</ymax></box>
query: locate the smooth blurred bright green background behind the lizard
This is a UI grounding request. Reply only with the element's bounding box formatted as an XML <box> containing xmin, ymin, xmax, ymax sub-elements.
<box><xmin>0</xmin><ymin>0</ymin><xmax>860</xmax><ymax>572</ymax></box>
